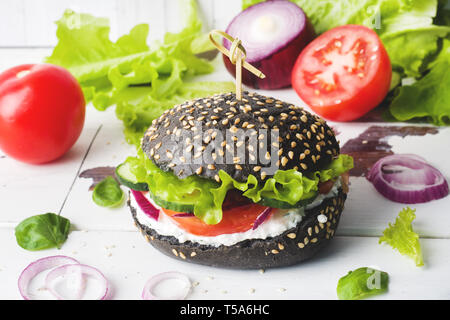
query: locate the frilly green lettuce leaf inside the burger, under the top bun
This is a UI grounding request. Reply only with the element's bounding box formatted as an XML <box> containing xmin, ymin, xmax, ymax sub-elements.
<box><xmin>126</xmin><ymin>149</ymin><xmax>353</xmax><ymax>224</ymax></box>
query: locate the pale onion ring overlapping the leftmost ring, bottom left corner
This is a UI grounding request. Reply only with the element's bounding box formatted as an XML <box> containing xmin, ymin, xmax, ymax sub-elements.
<box><xmin>45</xmin><ymin>264</ymin><xmax>109</xmax><ymax>300</ymax></box>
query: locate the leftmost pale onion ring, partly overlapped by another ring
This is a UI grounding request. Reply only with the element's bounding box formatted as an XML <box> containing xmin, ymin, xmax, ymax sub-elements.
<box><xmin>18</xmin><ymin>256</ymin><xmax>81</xmax><ymax>300</ymax></box>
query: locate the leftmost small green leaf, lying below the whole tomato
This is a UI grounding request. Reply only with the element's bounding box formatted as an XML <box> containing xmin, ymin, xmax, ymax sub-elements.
<box><xmin>15</xmin><ymin>213</ymin><xmax>70</xmax><ymax>251</ymax></box>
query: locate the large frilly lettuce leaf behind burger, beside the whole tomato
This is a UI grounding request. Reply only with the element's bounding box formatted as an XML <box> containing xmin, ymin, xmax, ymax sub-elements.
<box><xmin>46</xmin><ymin>0</ymin><xmax>234</xmax><ymax>146</ymax></box>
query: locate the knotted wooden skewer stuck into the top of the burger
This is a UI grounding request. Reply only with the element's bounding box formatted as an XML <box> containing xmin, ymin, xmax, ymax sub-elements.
<box><xmin>209</xmin><ymin>30</ymin><xmax>266</xmax><ymax>100</ymax></box>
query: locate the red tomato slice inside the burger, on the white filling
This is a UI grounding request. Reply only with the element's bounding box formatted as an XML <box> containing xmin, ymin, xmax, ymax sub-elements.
<box><xmin>161</xmin><ymin>204</ymin><xmax>270</xmax><ymax>237</ymax></box>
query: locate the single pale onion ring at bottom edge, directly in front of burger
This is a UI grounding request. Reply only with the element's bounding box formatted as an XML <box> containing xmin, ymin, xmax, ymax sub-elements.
<box><xmin>142</xmin><ymin>271</ymin><xmax>191</xmax><ymax>300</ymax></box>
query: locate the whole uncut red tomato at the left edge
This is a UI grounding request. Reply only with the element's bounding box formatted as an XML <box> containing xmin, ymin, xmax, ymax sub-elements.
<box><xmin>0</xmin><ymin>64</ymin><xmax>86</xmax><ymax>164</ymax></box>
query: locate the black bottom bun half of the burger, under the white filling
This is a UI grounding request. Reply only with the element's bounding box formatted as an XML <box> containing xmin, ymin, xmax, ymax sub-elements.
<box><xmin>128</xmin><ymin>188</ymin><xmax>347</xmax><ymax>269</ymax></box>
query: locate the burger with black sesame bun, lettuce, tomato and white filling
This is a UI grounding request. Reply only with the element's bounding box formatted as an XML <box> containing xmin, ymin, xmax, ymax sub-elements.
<box><xmin>117</xmin><ymin>92</ymin><xmax>353</xmax><ymax>269</ymax></box>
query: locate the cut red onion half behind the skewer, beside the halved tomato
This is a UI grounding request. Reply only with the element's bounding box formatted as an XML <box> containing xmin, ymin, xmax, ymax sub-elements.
<box><xmin>223</xmin><ymin>0</ymin><xmax>314</xmax><ymax>89</ymax></box>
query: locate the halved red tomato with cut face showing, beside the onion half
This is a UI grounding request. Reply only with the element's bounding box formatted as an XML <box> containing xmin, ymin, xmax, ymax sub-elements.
<box><xmin>292</xmin><ymin>25</ymin><xmax>392</xmax><ymax>121</ymax></box>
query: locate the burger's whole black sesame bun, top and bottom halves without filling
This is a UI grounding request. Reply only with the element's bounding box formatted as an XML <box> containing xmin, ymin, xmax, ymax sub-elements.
<box><xmin>132</xmin><ymin>92</ymin><xmax>347</xmax><ymax>269</ymax></box>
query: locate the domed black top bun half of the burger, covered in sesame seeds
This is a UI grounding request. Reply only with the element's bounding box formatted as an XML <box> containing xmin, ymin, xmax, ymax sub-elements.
<box><xmin>142</xmin><ymin>92</ymin><xmax>339</xmax><ymax>181</ymax></box>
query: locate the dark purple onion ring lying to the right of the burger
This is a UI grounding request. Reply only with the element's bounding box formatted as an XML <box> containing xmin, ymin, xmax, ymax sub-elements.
<box><xmin>367</xmin><ymin>154</ymin><xmax>449</xmax><ymax>204</ymax></box>
